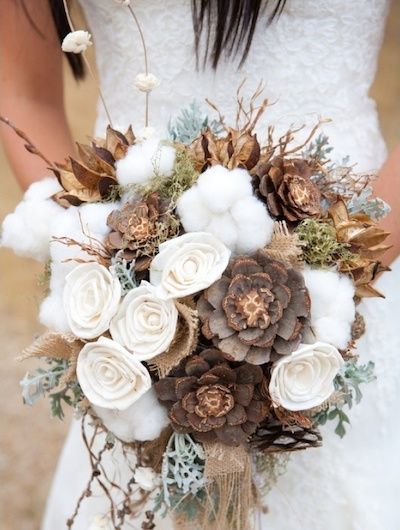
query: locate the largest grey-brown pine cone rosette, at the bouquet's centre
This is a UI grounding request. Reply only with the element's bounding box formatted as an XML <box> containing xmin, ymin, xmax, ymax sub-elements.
<box><xmin>197</xmin><ymin>250</ymin><xmax>310</xmax><ymax>364</ymax></box>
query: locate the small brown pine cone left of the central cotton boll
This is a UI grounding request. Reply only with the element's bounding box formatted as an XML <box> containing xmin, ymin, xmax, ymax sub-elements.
<box><xmin>106</xmin><ymin>193</ymin><xmax>178</xmax><ymax>272</ymax></box>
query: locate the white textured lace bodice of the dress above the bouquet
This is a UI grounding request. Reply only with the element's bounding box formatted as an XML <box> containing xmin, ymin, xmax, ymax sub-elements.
<box><xmin>81</xmin><ymin>0</ymin><xmax>389</xmax><ymax>170</ymax></box>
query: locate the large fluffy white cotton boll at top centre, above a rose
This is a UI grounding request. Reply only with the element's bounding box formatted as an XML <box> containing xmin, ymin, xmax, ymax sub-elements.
<box><xmin>177</xmin><ymin>166</ymin><xmax>274</xmax><ymax>253</ymax></box>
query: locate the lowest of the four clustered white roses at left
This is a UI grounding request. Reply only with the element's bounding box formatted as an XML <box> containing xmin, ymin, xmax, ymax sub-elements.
<box><xmin>76</xmin><ymin>337</ymin><xmax>151</xmax><ymax>410</ymax></box>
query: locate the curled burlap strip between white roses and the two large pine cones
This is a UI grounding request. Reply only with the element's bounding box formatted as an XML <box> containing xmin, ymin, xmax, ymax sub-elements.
<box><xmin>150</xmin><ymin>301</ymin><xmax>199</xmax><ymax>378</ymax></box>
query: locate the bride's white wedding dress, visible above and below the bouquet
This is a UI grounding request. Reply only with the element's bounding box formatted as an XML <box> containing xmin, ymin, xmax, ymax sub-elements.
<box><xmin>44</xmin><ymin>0</ymin><xmax>400</xmax><ymax>530</ymax></box>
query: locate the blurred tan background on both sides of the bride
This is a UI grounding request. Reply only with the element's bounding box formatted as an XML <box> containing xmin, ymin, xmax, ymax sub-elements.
<box><xmin>0</xmin><ymin>4</ymin><xmax>400</xmax><ymax>530</ymax></box>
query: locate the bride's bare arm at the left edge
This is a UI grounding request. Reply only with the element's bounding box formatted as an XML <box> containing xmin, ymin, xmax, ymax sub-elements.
<box><xmin>0</xmin><ymin>0</ymin><xmax>73</xmax><ymax>188</ymax></box>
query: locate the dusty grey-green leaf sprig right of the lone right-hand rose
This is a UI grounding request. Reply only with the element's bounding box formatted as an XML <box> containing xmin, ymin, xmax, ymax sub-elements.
<box><xmin>314</xmin><ymin>360</ymin><xmax>376</xmax><ymax>438</ymax></box>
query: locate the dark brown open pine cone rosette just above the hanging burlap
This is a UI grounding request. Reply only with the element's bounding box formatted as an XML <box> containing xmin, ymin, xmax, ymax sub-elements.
<box><xmin>155</xmin><ymin>349</ymin><xmax>270</xmax><ymax>446</ymax></box>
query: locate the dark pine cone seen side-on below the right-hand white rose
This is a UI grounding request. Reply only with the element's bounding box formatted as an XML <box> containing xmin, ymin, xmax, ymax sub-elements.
<box><xmin>250</xmin><ymin>417</ymin><xmax>322</xmax><ymax>453</ymax></box>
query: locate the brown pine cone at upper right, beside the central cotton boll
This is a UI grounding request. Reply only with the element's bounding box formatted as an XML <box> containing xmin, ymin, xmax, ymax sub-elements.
<box><xmin>253</xmin><ymin>156</ymin><xmax>322</xmax><ymax>222</ymax></box>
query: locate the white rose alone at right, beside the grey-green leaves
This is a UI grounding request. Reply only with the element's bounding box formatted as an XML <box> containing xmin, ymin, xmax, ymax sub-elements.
<box><xmin>269</xmin><ymin>342</ymin><xmax>344</xmax><ymax>411</ymax></box>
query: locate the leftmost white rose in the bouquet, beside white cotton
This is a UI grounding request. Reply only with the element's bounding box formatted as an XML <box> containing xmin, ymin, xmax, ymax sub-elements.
<box><xmin>63</xmin><ymin>263</ymin><xmax>121</xmax><ymax>339</ymax></box>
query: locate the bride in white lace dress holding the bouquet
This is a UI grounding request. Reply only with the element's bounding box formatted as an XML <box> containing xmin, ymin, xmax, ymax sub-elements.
<box><xmin>0</xmin><ymin>0</ymin><xmax>400</xmax><ymax>530</ymax></box>
